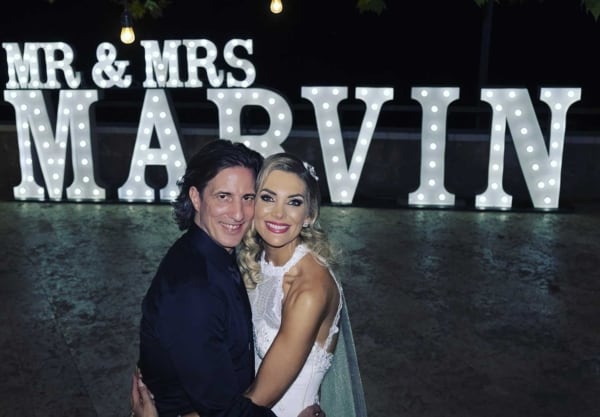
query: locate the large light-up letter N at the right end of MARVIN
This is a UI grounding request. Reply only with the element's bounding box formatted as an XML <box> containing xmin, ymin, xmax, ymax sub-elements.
<box><xmin>475</xmin><ymin>88</ymin><xmax>581</xmax><ymax>209</ymax></box>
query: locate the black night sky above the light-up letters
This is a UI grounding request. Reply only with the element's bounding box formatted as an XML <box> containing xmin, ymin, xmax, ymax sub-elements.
<box><xmin>0</xmin><ymin>0</ymin><xmax>600</xmax><ymax>112</ymax></box>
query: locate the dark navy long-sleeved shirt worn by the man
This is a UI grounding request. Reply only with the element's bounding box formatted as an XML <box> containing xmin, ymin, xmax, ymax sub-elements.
<box><xmin>139</xmin><ymin>224</ymin><xmax>274</xmax><ymax>417</ymax></box>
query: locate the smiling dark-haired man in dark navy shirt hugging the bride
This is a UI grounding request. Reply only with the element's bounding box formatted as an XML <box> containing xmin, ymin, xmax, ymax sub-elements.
<box><xmin>132</xmin><ymin>140</ymin><xmax>320</xmax><ymax>417</ymax></box>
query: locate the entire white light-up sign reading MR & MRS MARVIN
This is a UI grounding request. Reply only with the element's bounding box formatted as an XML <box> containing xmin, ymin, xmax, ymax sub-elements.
<box><xmin>2</xmin><ymin>39</ymin><xmax>581</xmax><ymax>210</ymax></box>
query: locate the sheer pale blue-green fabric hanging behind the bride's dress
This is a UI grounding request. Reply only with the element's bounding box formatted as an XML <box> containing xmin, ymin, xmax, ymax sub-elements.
<box><xmin>321</xmin><ymin>301</ymin><xmax>367</xmax><ymax>417</ymax></box>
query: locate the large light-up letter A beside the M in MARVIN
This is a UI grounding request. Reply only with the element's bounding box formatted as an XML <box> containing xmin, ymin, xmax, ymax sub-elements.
<box><xmin>119</xmin><ymin>89</ymin><xmax>185</xmax><ymax>202</ymax></box>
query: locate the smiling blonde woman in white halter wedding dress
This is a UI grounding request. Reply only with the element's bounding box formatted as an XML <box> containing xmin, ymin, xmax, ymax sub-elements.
<box><xmin>132</xmin><ymin>153</ymin><xmax>342</xmax><ymax>417</ymax></box>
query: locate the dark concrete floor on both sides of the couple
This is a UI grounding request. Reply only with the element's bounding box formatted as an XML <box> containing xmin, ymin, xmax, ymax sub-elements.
<box><xmin>0</xmin><ymin>202</ymin><xmax>600</xmax><ymax>417</ymax></box>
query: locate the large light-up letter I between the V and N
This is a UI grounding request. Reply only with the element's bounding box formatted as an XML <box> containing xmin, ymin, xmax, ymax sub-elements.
<box><xmin>408</xmin><ymin>87</ymin><xmax>459</xmax><ymax>206</ymax></box>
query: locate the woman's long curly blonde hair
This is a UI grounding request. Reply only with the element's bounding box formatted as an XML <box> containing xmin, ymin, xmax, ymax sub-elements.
<box><xmin>238</xmin><ymin>153</ymin><xmax>333</xmax><ymax>289</ymax></box>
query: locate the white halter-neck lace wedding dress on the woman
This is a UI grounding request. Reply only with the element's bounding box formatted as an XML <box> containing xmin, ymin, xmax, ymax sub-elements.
<box><xmin>248</xmin><ymin>245</ymin><xmax>343</xmax><ymax>417</ymax></box>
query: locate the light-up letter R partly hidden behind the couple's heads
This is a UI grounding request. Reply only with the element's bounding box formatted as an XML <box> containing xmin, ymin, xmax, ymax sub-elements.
<box><xmin>206</xmin><ymin>88</ymin><xmax>292</xmax><ymax>156</ymax></box>
